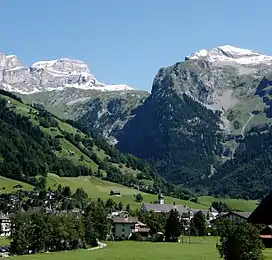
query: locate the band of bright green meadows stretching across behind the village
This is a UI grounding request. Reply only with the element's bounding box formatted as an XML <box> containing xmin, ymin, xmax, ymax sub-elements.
<box><xmin>0</xmin><ymin>174</ymin><xmax>256</xmax><ymax>211</ymax></box>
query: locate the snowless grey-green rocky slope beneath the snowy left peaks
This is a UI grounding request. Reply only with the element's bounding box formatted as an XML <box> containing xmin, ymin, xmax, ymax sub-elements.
<box><xmin>21</xmin><ymin>88</ymin><xmax>149</xmax><ymax>143</ymax></box>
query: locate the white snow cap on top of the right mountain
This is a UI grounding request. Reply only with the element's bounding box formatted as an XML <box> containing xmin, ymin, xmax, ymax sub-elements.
<box><xmin>186</xmin><ymin>45</ymin><xmax>272</xmax><ymax>65</ymax></box>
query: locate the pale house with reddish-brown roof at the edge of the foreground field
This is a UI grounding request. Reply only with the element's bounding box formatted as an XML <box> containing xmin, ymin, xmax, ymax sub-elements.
<box><xmin>111</xmin><ymin>217</ymin><xmax>150</xmax><ymax>240</ymax></box>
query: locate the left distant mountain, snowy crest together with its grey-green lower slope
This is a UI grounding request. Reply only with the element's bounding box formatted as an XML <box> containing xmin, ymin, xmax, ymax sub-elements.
<box><xmin>0</xmin><ymin>54</ymin><xmax>149</xmax><ymax>143</ymax></box>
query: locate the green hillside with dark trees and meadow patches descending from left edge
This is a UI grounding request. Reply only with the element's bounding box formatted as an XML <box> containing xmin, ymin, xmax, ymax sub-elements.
<box><xmin>0</xmin><ymin>91</ymin><xmax>196</xmax><ymax>199</ymax></box>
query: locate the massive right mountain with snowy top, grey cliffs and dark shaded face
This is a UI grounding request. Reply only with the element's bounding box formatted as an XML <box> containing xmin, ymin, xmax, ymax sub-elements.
<box><xmin>117</xmin><ymin>46</ymin><xmax>272</xmax><ymax>193</ymax></box>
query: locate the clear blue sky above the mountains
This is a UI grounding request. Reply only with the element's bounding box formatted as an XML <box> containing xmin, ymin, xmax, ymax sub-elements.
<box><xmin>0</xmin><ymin>0</ymin><xmax>272</xmax><ymax>90</ymax></box>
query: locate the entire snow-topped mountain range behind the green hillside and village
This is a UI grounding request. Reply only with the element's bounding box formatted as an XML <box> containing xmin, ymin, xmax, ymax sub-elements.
<box><xmin>0</xmin><ymin>45</ymin><xmax>272</xmax><ymax>198</ymax></box>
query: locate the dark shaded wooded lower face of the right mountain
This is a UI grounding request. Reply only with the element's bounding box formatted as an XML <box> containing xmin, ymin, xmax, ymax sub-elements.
<box><xmin>117</xmin><ymin>77</ymin><xmax>220</xmax><ymax>187</ymax></box>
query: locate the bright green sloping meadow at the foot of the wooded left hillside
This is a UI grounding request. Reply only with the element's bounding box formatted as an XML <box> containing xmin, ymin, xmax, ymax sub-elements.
<box><xmin>47</xmin><ymin>174</ymin><xmax>208</xmax><ymax>209</ymax></box>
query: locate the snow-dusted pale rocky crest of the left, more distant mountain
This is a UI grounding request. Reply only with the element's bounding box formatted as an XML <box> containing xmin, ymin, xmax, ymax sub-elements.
<box><xmin>0</xmin><ymin>53</ymin><xmax>132</xmax><ymax>94</ymax></box>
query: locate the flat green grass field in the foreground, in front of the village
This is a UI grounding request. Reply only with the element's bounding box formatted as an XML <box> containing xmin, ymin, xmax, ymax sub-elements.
<box><xmin>7</xmin><ymin>241</ymin><xmax>272</xmax><ymax>260</ymax></box>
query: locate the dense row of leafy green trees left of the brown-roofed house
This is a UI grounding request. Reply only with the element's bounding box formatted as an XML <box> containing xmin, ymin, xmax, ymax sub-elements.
<box><xmin>10</xmin><ymin>201</ymin><xmax>108</xmax><ymax>255</ymax></box>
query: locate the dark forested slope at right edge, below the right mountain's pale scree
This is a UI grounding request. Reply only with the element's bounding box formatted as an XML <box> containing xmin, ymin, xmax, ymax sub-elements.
<box><xmin>210</xmin><ymin>125</ymin><xmax>272</xmax><ymax>199</ymax></box>
